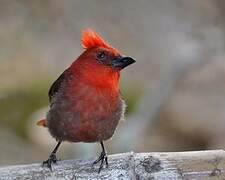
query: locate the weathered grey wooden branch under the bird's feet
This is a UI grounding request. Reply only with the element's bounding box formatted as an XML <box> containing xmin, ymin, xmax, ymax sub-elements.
<box><xmin>0</xmin><ymin>150</ymin><xmax>225</xmax><ymax>180</ymax></box>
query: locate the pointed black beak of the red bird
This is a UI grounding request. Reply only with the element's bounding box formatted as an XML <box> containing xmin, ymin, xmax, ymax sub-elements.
<box><xmin>112</xmin><ymin>57</ymin><xmax>136</xmax><ymax>69</ymax></box>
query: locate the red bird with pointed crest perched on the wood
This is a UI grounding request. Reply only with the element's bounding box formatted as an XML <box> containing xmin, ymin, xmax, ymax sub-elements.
<box><xmin>37</xmin><ymin>29</ymin><xmax>135</xmax><ymax>172</ymax></box>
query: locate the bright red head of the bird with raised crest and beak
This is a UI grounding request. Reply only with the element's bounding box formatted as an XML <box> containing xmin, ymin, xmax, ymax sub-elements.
<box><xmin>70</xmin><ymin>29</ymin><xmax>135</xmax><ymax>90</ymax></box>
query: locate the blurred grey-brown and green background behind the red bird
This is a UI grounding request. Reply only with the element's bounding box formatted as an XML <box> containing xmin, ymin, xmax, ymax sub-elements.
<box><xmin>0</xmin><ymin>0</ymin><xmax>225</xmax><ymax>166</ymax></box>
